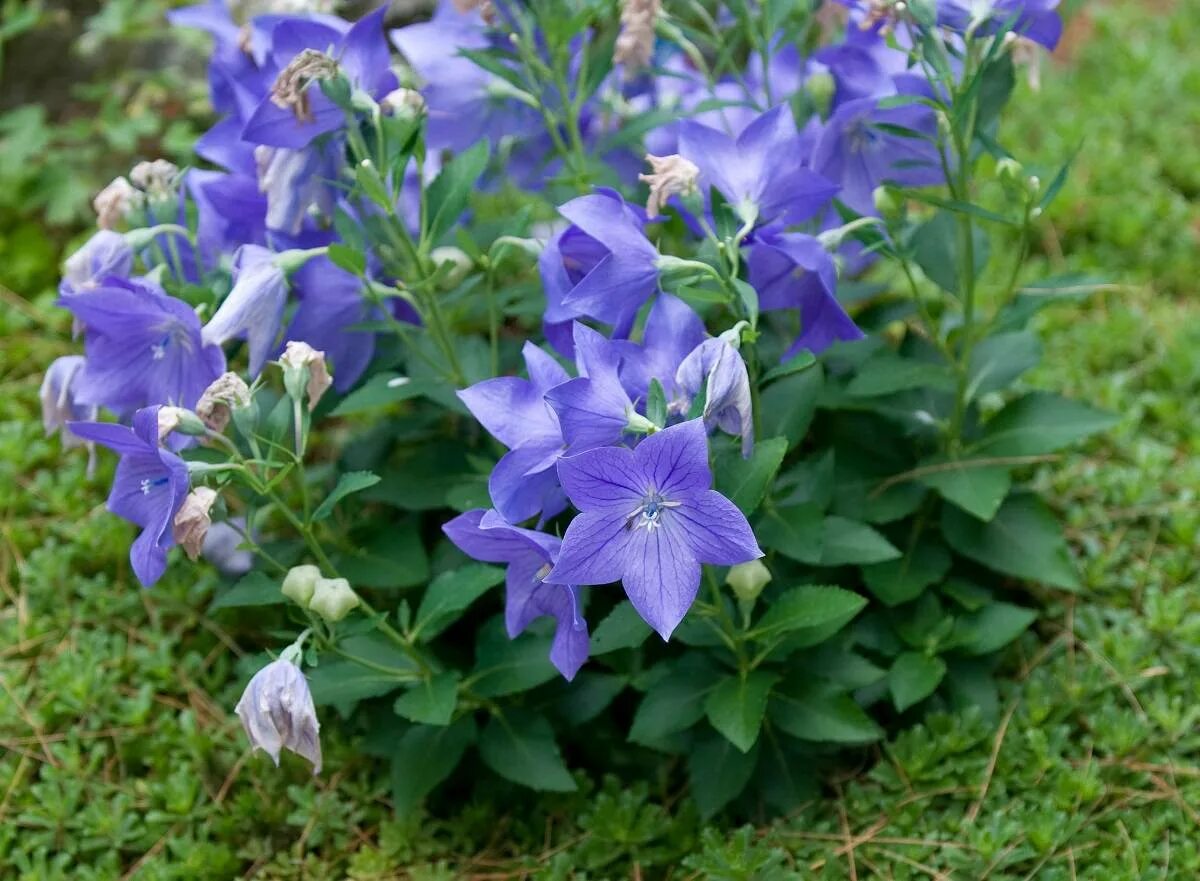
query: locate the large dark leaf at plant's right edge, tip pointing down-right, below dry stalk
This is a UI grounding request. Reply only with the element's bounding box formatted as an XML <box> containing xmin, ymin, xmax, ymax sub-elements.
<box><xmin>942</xmin><ymin>495</ymin><xmax>1080</xmax><ymax>591</ymax></box>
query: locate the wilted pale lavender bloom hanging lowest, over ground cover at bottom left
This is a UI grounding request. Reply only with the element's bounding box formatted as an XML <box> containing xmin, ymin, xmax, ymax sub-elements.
<box><xmin>234</xmin><ymin>646</ymin><xmax>320</xmax><ymax>774</ymax></box>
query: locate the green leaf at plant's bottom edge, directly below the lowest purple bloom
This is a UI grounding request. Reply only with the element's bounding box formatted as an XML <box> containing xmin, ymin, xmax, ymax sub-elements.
<box><xmin>479</xmin><ymin>711</ymin><xmax>576</xmax><ymax>792</ymax></box>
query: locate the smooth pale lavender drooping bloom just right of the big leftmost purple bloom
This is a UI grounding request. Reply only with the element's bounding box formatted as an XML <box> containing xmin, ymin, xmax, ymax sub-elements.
<box><xmin>200</xmin><ymin>245</ymin><xmax>288</xmax><ymax>376</ymax></box>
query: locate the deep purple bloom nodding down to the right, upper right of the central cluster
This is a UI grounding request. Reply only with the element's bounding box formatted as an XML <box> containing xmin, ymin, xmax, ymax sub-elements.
<box><xmin>746</xmin><ymin>233</ymin><xmax>863</xmax><ymax>358</ymax></box>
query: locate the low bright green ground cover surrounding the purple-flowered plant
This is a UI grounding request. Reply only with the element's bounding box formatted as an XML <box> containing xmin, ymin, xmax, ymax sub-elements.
<box><xmin>0</xmin><ymin>0</ymin><xmax>1200</xmax><ymax>881</ymax></box>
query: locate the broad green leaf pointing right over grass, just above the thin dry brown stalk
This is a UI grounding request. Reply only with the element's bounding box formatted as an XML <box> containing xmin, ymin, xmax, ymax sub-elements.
<box><xmin>971</xmin><ymin>391</ymin><xmax>1118</xmax><ymax>456</ymax></box>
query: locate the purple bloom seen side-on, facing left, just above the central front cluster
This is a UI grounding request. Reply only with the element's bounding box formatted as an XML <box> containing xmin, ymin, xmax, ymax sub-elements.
<box><xmin>542</xmin><ymin>190</ymin><xmax>659</xmax><ymax>335</ymax></box>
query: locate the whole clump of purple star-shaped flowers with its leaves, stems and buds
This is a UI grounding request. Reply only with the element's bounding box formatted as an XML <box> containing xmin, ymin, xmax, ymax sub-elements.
<box><xmin>35</xmin><ymin>0</ymin><xmax>1112</xmax><ymax>814</ymax></box>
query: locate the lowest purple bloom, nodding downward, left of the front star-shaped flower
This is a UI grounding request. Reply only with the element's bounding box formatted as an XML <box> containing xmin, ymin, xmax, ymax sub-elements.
<box><xmin>442</xmin><ymin>510</ymin><xmax>588</xmax><ymax>679</ymax></box>
